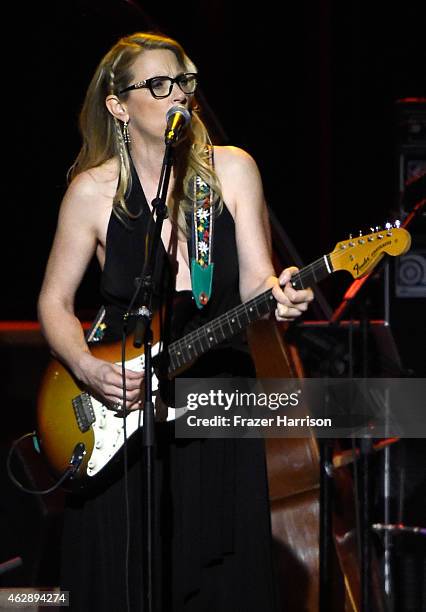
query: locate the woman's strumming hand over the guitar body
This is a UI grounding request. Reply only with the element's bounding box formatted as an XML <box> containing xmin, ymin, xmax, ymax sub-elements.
<box><xmin>76</xmin><ymin>353</ymin><xmax>144</xmax><ymax>410</ymax></box>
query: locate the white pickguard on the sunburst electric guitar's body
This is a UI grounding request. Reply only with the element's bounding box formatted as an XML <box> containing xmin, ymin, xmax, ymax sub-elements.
<box><xmin>87</xmin><ymin>342</ymin><xmax>188</xmax><ymax>476</ymax></box>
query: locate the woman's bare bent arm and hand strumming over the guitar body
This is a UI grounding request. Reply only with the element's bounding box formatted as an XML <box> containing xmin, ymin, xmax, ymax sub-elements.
<box><xmin>38</xmin><ymin>173</ymin><xmax>141</xmax><ymax>403</ymax></box>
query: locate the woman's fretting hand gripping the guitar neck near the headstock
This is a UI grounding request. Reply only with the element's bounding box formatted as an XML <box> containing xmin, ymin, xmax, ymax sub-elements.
<box><xmin>272</xmin><ymin>266</ymin><xmax>314</xmax><ymax>321</ymax></box>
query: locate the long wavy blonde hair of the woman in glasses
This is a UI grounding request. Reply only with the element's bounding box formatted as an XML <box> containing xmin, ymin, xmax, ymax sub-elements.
<box><xmin>68</xmin><ymin>32</ymin><xmax>222</xmax><ymax>233</ymax></box>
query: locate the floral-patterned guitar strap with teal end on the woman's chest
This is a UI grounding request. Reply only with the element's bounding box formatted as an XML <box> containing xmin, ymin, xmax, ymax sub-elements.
<box><xmin>191</xmin><ymin>147</ymin><xmax>214</xmax><ymax>308</ymax></box>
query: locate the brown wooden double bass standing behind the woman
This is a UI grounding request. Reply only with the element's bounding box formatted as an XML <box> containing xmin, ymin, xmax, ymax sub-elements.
<box><xmin>248</xmin><ymin>320</ymin><xmax>384</xmax><ymax>612</ymax></box>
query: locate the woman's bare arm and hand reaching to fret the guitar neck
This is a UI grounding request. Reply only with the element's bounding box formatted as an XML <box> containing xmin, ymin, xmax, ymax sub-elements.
<box><xmin>216</xmin><ymin>147</ymin><xmax>313</xmax><ymax>321</ymax></box>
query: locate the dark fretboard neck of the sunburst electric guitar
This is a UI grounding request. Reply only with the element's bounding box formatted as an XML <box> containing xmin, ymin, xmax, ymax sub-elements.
<box><xmin>169</xmin><ymin>255</ymin><xmax>333</xmax><ymax>375</ymax></box>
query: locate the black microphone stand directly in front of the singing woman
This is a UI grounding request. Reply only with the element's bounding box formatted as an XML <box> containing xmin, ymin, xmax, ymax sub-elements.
<box><xmin>125</xmin><ymin>142</ymin><xmax>173</xmax><ymax>612</ymax></box>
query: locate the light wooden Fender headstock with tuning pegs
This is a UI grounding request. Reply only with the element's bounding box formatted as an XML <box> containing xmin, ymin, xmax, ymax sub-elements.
<box><xmin>329</xmin><ymin>222</ymin><xmax>411</xmax><ymax>278</ymax></box>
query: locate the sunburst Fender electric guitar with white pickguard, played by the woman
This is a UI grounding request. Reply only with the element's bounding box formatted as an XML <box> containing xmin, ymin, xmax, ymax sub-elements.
<box><xmin>37</xmin><ymin>227</ymin><xmax>411</xmax><ymax>488</ymax></box>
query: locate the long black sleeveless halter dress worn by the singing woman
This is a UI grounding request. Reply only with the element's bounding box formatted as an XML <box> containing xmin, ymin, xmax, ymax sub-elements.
<box><xmin>61</xmin><ymin>167</ymin><xmax>277</xmax><ymax>612</ymax></box>
